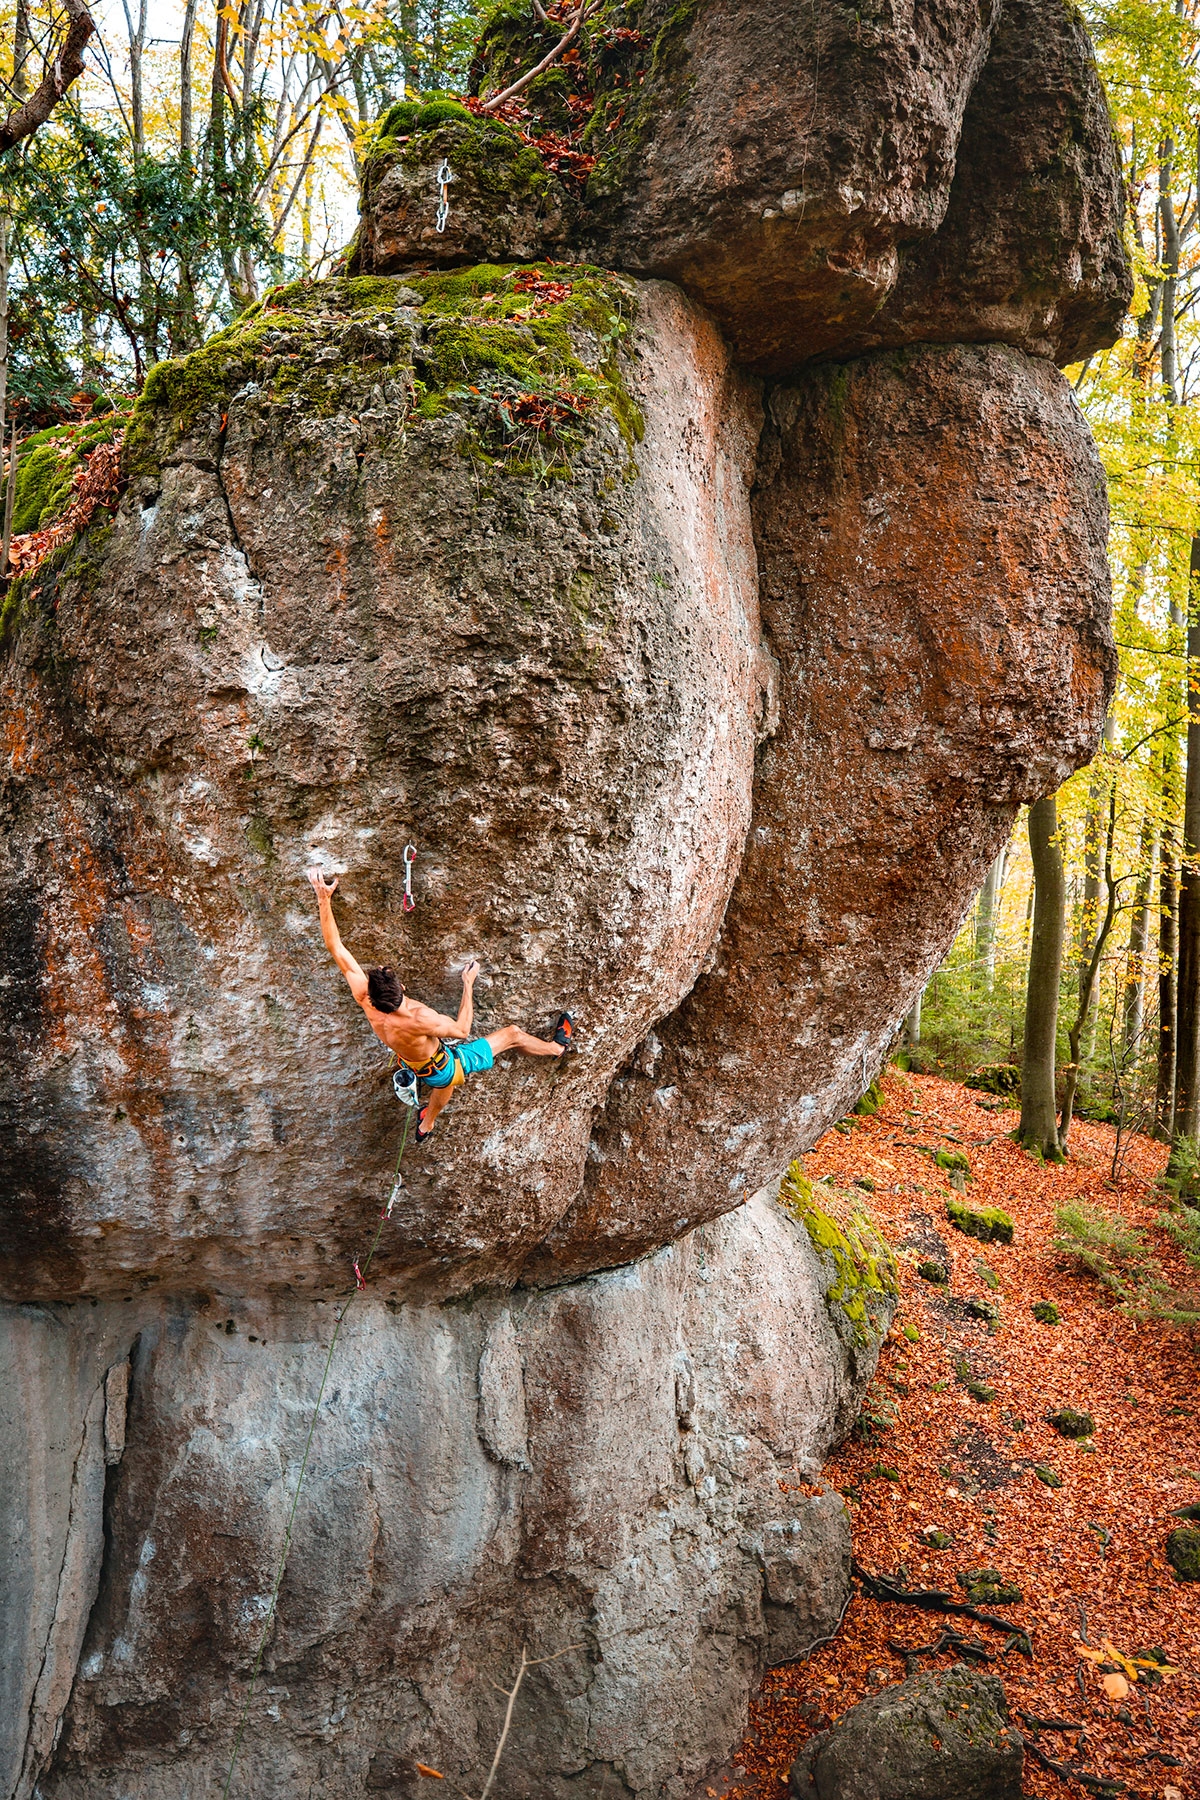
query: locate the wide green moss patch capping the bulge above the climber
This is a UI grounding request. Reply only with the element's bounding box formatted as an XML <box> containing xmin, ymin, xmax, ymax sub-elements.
<box><xmin>130</xmin><ymin>263</ymin><xmax>642</xmax><ymax>473</ymax></box>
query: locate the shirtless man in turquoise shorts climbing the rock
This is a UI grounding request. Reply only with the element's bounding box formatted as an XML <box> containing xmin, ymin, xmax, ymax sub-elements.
<box><xmin>308</xmin><ymin>869</ymin><xmax>574</xmax><ymax>1143</ymax></box>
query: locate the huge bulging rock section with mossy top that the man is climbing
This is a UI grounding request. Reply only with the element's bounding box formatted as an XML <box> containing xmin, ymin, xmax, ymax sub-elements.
<box><xmin>0</xmin><ymin>268</ymin><xmax>774</xmax><ymax>1300</ymax></box>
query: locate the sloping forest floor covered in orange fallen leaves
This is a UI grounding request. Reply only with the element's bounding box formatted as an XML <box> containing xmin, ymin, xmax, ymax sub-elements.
<box><xmin>696</xmin><ymin>1071</ymin><xmax>1200</xmax><ymax>1800</ymax></box>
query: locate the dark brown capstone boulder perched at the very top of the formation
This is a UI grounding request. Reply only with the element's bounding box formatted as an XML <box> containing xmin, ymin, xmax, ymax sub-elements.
<box><xmin>415</xmin><ymin>0</ymin><xmax>1132</xmax><ymax>374</ymax></box>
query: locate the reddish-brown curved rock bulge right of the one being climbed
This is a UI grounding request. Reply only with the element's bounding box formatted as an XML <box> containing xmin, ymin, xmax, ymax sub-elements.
<box><xmin>527</xmin><ymin>346</ymin><xmax>1115</xmax><ymax>1282</ymax></box>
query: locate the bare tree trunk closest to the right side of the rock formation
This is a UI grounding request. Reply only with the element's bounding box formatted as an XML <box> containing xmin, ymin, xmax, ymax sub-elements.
<box><xmin>1016</xmin><ymin>794</ymin><xmax>1067</xmax><ymax>1163</ymax></box>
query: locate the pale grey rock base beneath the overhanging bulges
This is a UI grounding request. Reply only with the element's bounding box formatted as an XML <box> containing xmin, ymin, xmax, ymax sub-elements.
<box><xmin>0</xmin><ymin>1195</ymin><xmax>887</xmax><ymax>1800</ymax></box>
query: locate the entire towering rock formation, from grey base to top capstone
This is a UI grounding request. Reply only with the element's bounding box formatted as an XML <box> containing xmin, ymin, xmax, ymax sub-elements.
<box><xmin>0</xmin><ymin>0</ymin><xmax>1128</xmax><ymax>1800</ymax></box>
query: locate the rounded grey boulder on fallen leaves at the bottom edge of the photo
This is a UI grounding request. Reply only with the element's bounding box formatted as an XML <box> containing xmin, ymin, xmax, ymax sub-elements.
<box><xmin>788</xmin><ymin>1663</ymin><xmax>1024</xmax><ymax>1800</ymax></box>
